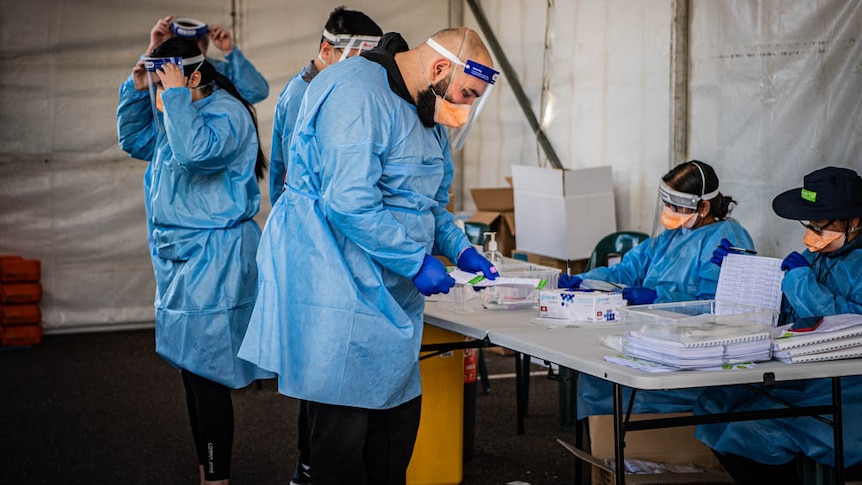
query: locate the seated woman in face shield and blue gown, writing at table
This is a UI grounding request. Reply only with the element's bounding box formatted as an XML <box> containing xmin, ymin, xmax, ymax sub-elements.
<box><xmin>560</xmin><ymin>160</ymin><xmax>754</xmax><ymax>419</ymax></box>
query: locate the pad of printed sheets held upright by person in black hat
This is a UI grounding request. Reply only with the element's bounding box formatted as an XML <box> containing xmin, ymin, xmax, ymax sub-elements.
<box><xmin>715</xmin><ymin>253</ymin><xmax>784</xmax><ymax>310</ymax></box>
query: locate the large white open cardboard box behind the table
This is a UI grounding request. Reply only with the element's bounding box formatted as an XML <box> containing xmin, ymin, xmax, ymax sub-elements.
<box><xmin>512</xmin><ymin>165</ymin><xmax>617</xmax><ymax>260</ymax></box>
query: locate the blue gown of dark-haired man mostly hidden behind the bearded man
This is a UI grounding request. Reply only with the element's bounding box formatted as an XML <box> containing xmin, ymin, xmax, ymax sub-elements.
<box><xmin>269</xmin><ymin>69</ymin><xmax>308</xmax><ymax>206</ymax></box>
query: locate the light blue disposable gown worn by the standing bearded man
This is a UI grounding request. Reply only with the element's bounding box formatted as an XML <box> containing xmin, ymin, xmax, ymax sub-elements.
<box><xmin>239</xmin><ymin>56</ymin><xmax>470</xmax><ymax>409</ymax></box>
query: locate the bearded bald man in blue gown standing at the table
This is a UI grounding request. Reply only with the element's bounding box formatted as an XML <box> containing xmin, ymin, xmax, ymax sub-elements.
<box><xmin>239</xmin><ymin>27</ymin><xmax>497</xmax><ymax>485</ymax></box>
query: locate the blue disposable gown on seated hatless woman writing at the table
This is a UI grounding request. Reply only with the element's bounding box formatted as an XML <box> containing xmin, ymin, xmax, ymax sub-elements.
<box><xmin>578</xmin><ymin>220</ymin><xmax>754</xmax><ymax>418</ymax></box>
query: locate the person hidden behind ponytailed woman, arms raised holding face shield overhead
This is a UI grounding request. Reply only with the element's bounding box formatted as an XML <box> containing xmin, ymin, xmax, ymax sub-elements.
<box><xmin>147</xmin><ymin>15</ymin><xmax>269</xmax><ymax>104</ymax></box>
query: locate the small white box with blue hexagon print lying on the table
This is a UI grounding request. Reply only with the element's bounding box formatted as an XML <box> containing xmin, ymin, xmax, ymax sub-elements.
<box><xmin>539</xmin><ymin>289</ymin><xmax>626</xmax><ymax>323</ymax></box>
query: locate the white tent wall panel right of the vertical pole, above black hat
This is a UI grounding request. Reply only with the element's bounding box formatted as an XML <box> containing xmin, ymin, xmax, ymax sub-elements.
<box><xmin>689</xmin><ymin>0</ymin><xmax>862</xmax><ymax>257</ymax></box>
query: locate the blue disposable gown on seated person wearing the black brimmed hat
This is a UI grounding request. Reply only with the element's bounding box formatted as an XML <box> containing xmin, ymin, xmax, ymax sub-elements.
<box><xmin>695</xmin><ymin>241</ymin><xmax>862</xmax><ymax>466</ymax></box>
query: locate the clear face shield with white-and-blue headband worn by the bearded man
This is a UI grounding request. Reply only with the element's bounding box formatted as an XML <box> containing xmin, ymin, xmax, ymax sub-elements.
<box><xmin>425</xmin><ymin>36</ymin><xmax>500</xmax><ymax>150</ymax></box>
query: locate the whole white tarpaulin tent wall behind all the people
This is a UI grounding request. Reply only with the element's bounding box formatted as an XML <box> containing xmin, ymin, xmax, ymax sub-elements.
<box><xmin>0</xmin><ymin>0</ymin><xmax>862</xmax><ymax>332</ymax></box>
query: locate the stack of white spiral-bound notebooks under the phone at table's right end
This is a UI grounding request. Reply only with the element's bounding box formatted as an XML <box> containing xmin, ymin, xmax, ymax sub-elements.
<box><xmin>772</xmin><ymin>313</ymin><xmax>862</xmax><ymax>363</ymax></box>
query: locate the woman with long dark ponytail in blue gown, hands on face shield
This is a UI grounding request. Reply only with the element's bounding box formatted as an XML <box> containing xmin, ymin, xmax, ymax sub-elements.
<box><xmin>117</xmin><ymin>37</ymin><xmax>273</xmax><ymax>483</ymax></box>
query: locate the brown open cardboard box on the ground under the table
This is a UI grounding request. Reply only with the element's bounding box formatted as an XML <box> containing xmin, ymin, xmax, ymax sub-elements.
<box><xmin>557</xmin><ymin>413</ymin><xmax>734</xmax><ymax>485</ymax></box>
